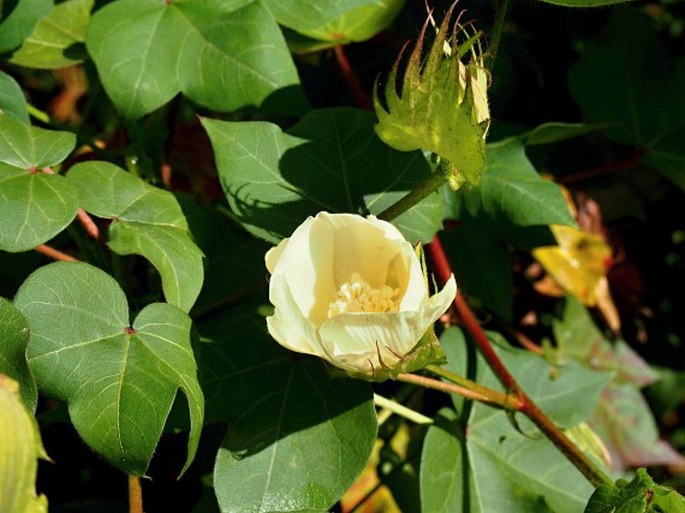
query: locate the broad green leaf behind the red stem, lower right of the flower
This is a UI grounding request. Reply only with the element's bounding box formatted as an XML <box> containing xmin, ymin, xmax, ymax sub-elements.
<box><xmin>421</xmin><ymin>328</ymin><xmax>611</xmax><ymax>513</ymax></box>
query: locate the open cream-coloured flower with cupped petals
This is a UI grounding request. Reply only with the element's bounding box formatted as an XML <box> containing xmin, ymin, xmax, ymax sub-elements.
<box><xmin>266</xmin><ymin>212</ymin><xmax>457</xmax><ymax>379</ymax></box>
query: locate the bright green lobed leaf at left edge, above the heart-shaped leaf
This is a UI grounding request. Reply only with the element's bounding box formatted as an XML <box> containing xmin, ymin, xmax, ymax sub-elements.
<box><xmin>0</xmin><ymin>114</ymin><xmax>78</xmax><ymax>251</ymax></box>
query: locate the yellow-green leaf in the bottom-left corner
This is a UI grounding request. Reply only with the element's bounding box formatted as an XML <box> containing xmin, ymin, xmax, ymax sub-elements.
<box><xmin>0</xmin><ymin>374</ymin><xmax>48</xmax><ymax>513</ymax></box>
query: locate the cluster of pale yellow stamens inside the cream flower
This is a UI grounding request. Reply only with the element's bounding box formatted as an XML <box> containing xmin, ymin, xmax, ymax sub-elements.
<box><xmin>328</xmin><ymin>273</ymin><xmax>400</xmax><ymax>318</ymax></box>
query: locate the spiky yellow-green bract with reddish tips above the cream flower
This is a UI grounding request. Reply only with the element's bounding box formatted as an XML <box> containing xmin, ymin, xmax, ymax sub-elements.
<box><xmin>374</xmin><ymin>6</ymin><xmax>490</xmax><ymax>189</ymax></box>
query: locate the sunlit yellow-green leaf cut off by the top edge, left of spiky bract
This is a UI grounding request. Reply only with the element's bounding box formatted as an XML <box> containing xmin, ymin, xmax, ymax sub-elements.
<box><xmin>264</xmin><ymin>0</ymin><xmax>405</xmax><ymax>43</ymax></box>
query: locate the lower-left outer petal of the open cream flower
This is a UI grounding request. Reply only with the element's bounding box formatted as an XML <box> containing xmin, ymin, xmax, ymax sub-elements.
<box><xmin>266</xmin><ymin>274</ymin><xmax>328</xmax><ymax>359</ymax></box>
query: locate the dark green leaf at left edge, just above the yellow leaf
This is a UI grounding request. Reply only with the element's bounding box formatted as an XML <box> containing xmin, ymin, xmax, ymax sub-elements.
<box><xmin>0</xmin><ymin>297</ymin><xmax>38</xmax><ymax>411</ymax></box>
